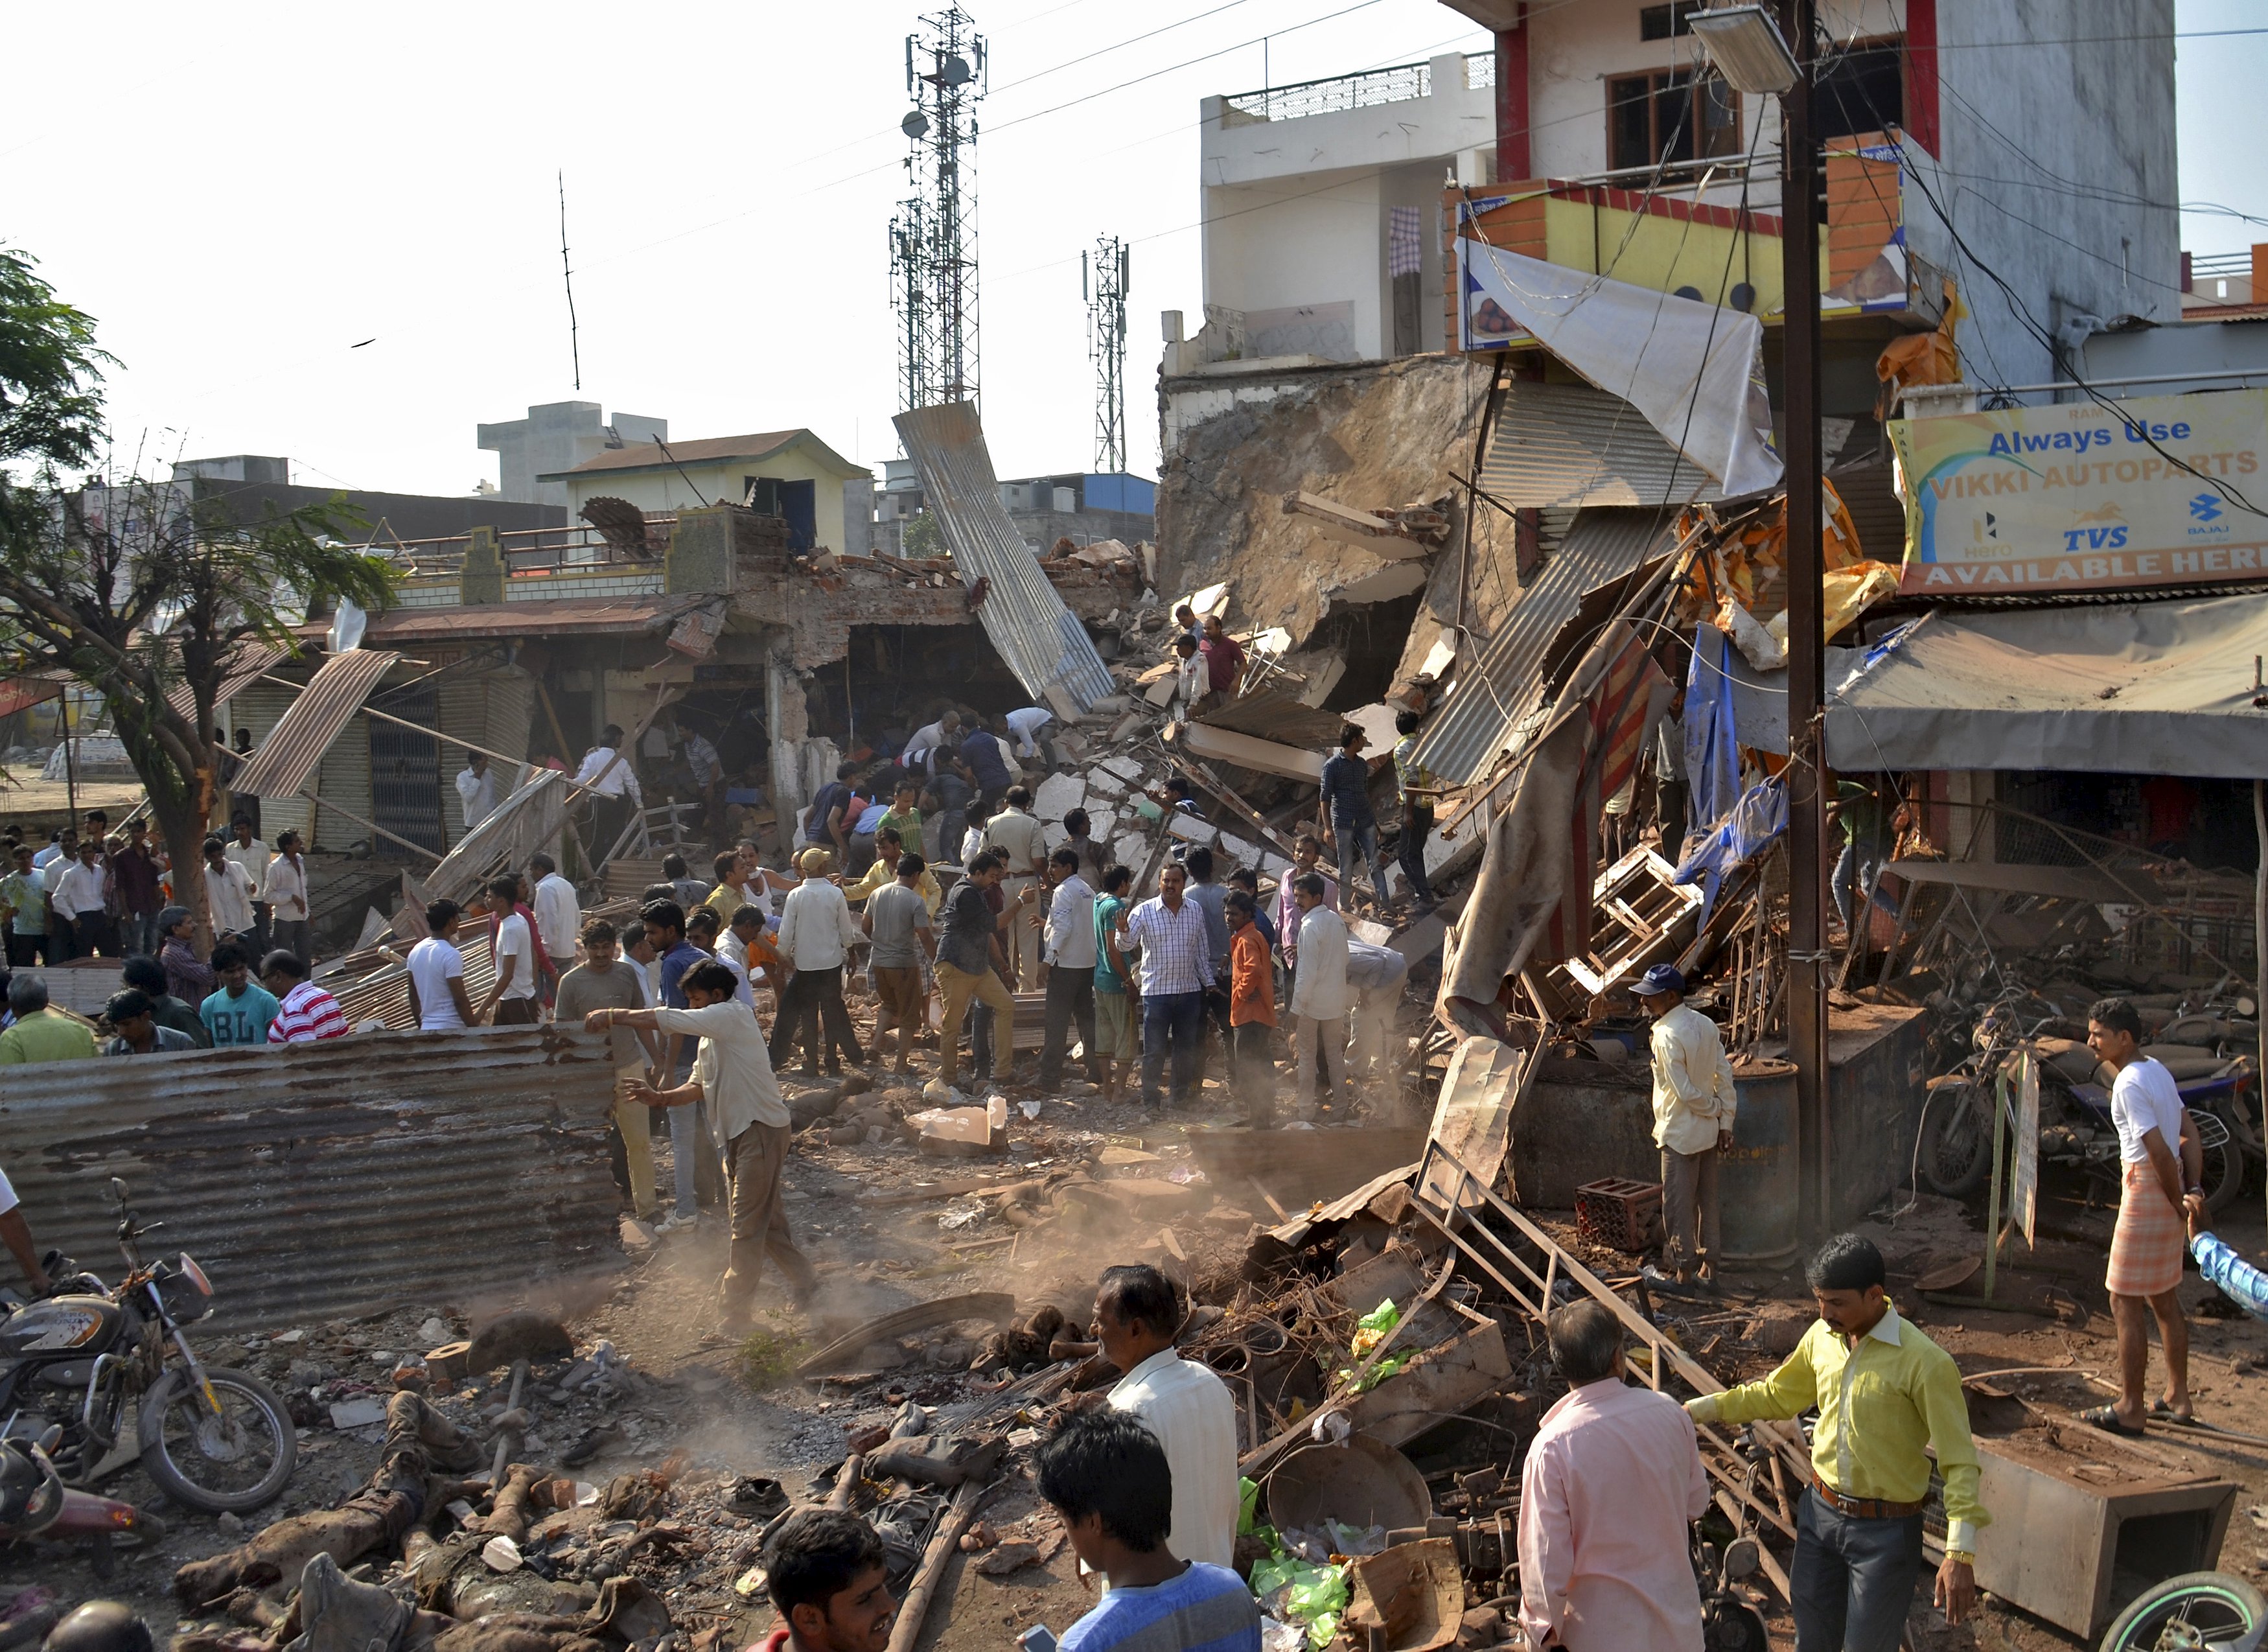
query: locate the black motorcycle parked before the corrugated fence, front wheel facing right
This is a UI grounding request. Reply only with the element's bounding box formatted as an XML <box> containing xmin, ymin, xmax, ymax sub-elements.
<box><xmin>0</xmin><ymin>1178</ymin><xmax>299</xmax><ymax>1513</ymax></box>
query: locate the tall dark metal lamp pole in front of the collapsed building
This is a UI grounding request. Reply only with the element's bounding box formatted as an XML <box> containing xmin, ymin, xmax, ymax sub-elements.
<box><xmin>1781</xmin><ymin>0</ymin><xmax>1835</xmax><ymax>1237</ymax></box>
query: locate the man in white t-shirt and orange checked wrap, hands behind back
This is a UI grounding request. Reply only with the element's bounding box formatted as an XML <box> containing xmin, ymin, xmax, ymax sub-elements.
<box><xmin>2080</xmin><ymin>999</ymin><xmax>2204</xmax><ymax>1434</ymax></box>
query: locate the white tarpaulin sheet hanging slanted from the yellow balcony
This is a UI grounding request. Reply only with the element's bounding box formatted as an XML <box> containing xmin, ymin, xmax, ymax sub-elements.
<box><xmin>1456</xmin><ymin>238</ymin><xmax>1781</xmax><ymax>504</ymax></box>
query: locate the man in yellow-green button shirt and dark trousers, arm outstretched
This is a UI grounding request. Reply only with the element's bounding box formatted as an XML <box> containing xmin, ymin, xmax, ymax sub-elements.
<box><xmin>1685</xmin><ymin>1232</ymin><xmax>1991</xmax><ymax>1652</ymax></box>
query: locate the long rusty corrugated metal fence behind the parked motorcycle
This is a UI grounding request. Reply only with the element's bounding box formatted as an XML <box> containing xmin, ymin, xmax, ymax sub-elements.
<box><xmin>0</xmin><ymin>1028</ymin><xmax>617</xmax><ymax>1345</ymax></box>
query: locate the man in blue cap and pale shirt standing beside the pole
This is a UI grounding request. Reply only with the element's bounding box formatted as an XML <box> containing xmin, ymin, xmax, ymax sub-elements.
<box><xmin>1633</xmin><ymin>964</ymin><xmax>1740</xmax><ymax>1285</ymax></box>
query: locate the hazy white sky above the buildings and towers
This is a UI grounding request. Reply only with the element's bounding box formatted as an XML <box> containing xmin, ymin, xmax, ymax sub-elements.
<box><xmin>0</xmin><ymin>0</ymin><xmax>2268</xmax><ymax>504</ymax></box>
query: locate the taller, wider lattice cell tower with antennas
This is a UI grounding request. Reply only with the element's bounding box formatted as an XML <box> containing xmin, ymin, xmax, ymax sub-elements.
<box><xmin>889</xmin><ymin>5</ymin><xmax>989</xmax><ymax>408</ymax></box>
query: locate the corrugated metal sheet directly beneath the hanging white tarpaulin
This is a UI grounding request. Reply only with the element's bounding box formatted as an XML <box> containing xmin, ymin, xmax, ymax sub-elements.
<box><xmin>1481</xmin><ymin>379</ymin><xmax>1719</xmax><ymax>508</ymax></box>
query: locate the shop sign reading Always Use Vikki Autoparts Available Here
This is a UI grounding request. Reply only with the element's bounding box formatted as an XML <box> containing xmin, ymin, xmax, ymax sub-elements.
<box><xmin>1890</xmin><ymin>390</ymin><xmax>2268</xmax><ymax>597</ymax></box>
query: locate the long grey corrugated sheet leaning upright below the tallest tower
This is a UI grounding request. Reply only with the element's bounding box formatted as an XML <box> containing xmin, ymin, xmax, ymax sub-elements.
<box><xmin>896</xmin><ymin>402</ymin><xmax>1111</xmax><ymax>715</ymax></box>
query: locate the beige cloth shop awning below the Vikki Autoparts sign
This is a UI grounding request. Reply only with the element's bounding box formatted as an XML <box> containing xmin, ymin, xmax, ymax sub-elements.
<box><xmin>1826</xmin><ymin>597</ymin><xmax>2268</xmax><ymax>780</ymax></box>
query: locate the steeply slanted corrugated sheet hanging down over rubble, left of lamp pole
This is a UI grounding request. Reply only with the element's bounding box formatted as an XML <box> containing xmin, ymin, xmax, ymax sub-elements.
<box><xmin>1415</xmin><ymin>508</ymin><xmax>1676</xmax><ymax>785</ymax></box>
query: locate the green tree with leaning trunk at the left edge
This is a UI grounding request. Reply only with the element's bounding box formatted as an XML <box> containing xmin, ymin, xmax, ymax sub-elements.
<box><xmin>0</xmin><ymin>250</ymin><xmax>395</xmax><ymax>944</ymax></box>
